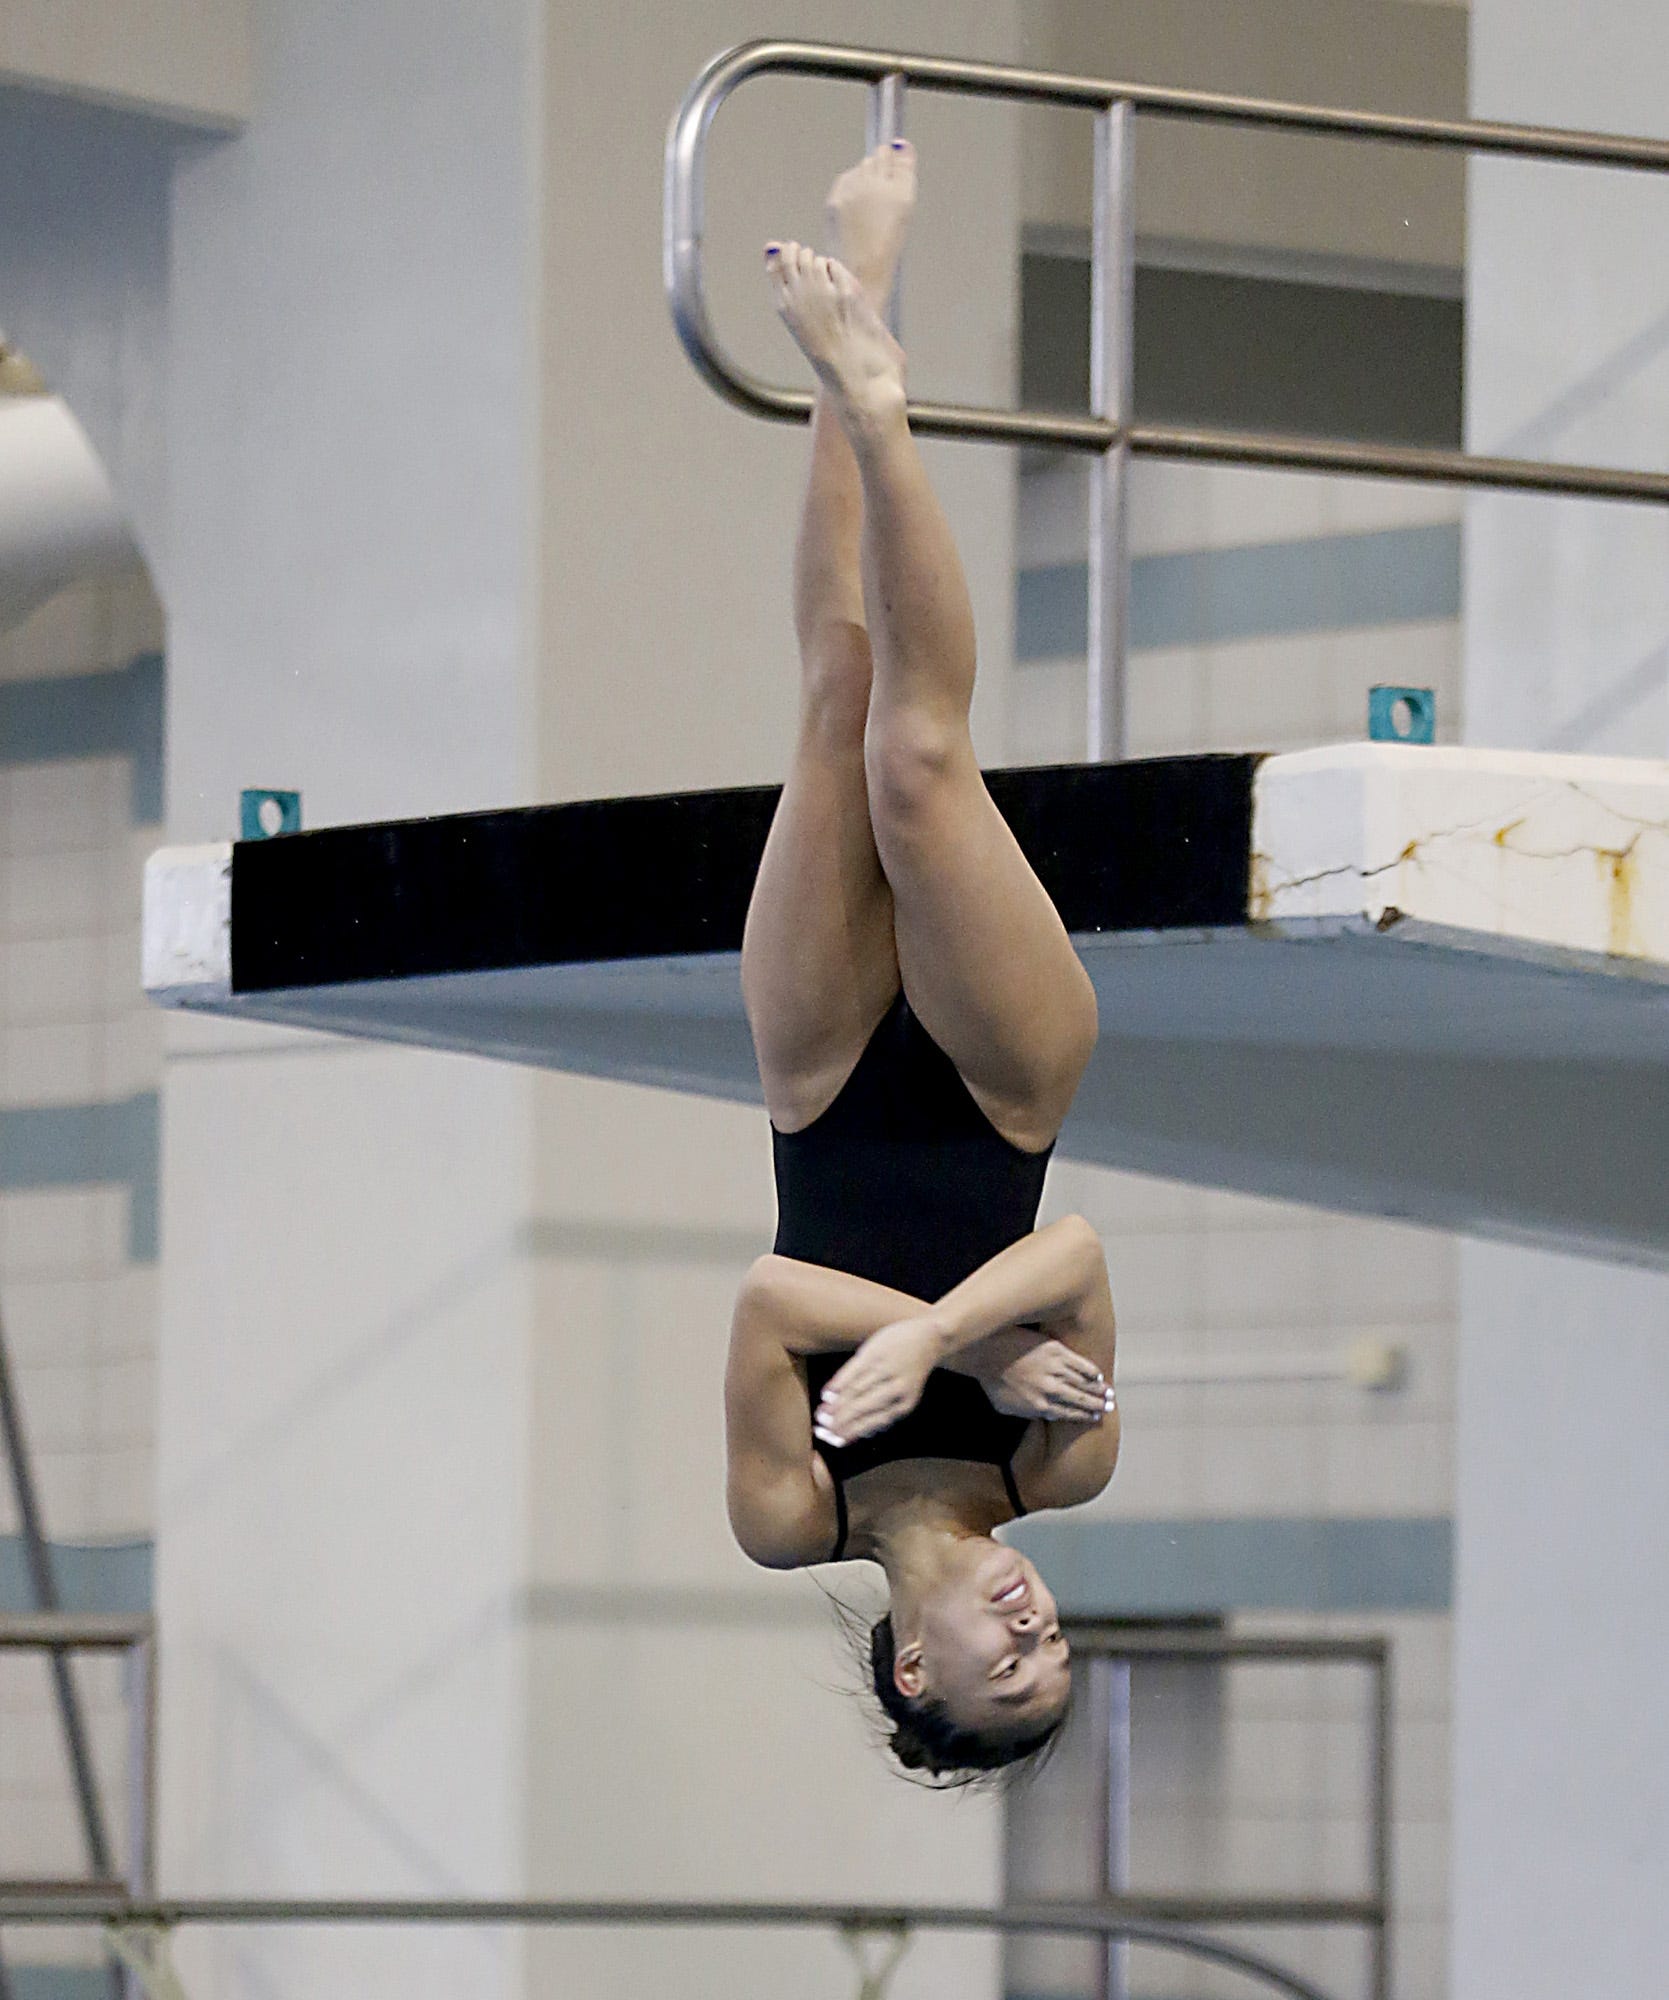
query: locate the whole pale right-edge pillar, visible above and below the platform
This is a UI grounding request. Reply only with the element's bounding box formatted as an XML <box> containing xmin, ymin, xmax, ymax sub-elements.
<box><xmin>1453</xmin><ymin>0</ymin><xmax>1669</xmax><ymax>2000</ymax></box>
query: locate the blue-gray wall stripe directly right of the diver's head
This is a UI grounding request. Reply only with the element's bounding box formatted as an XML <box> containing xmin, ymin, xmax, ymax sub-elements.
<box><xmin>1013</xmin><ymin>1518</ymin><xmax>1455</xmax><ymax>1618</ymax></box>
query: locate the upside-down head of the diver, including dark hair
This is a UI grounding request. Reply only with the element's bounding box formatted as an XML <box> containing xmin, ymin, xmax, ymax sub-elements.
<box><xmin>871</xmin><ymin>1536</ymin><xmax>1073</xmax><ymax>1776</ymax></box>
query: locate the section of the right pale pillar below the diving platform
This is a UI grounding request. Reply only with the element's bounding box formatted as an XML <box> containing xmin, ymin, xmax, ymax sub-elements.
<box><xmin>1453</xmin><ymin>1244</ymin><xmax>1669</xmax><ymax>2000</ymax></box>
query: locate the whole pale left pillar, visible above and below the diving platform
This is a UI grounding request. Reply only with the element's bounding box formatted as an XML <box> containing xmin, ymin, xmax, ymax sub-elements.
<box><xmin>158</xmin><ymin>0</ymin><xmax>536</xmax><ymax>1996</ymax></box>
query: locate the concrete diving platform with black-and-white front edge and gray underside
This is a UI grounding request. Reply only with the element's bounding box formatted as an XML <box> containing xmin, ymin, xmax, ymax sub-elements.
<box><xmin>144</xmin><ymin>744</ymin><xmax>1669</xmax><ymax>1268</ymax></box>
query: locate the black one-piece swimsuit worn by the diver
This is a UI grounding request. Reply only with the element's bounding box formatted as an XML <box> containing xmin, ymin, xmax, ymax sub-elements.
<box><xmin>770</xmin><ymin>992</ymin><xmax>1053</xmax><ymax>1562</ymax></box>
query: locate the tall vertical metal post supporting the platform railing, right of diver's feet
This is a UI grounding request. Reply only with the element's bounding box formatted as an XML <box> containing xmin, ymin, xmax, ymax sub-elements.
<box><xmin>1087</xmin><ymin>102</ymin><xmax>1137</xmax><ymax>764</ymax></box>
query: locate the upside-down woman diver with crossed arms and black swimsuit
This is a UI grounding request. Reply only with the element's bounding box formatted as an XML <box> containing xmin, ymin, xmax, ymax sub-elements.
<box><xmin>724</xmin><ymin>142</ymin><xmax>1119</xmax><ymax>1776</ymax></box>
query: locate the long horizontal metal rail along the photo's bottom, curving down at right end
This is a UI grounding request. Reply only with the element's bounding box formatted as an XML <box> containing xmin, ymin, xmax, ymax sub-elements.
<box><xmin>0</xmin><ymin>1896</ymin><xmax>1329</xmax><ymax>2000</ymax></box>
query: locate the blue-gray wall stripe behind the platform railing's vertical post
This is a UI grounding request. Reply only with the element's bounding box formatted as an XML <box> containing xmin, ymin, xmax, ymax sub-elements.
<box><xmin>1000</xmin><ymin>522</ymin><xmax>1461</xmax><ymax>662</ymax></box>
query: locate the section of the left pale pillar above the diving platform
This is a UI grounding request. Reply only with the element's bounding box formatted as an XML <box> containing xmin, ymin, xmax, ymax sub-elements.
<box><xmin>168</xmin><ymin>0</ymin><xmax>536</xmax><ymax>840</ymax></box>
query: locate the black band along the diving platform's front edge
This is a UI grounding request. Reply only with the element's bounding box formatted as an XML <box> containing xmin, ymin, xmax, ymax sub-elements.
<box><xmin>232</xmin><ymin>756</ymin><xmax>1259</xmax><ymax>994</ymax></box>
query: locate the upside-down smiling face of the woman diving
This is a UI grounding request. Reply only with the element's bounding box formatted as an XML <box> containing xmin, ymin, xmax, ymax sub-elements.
<box><xmin>897</xmin><ymin>1542</ymin><xmax>1073</xmax><ymax>1738</ymax></box>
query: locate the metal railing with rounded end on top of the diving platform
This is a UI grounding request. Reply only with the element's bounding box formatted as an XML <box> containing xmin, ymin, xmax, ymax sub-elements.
<box><xmin>662</xmin><ymin>40</ymin><xmax>1669</xmax><ymax>760</ymax></box>
